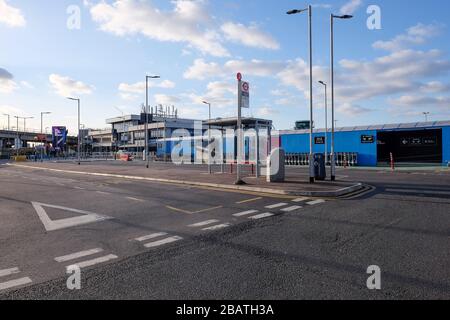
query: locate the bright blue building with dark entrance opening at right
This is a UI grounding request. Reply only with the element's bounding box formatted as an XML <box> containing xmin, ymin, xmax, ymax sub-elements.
<box><xmin>279</xmin><ymin>121</ymin><xmax>450</xmax><ymax>166</ymax></box>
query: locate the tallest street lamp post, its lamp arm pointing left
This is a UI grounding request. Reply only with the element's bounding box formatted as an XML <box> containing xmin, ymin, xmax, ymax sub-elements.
<box><xmin>287</xmin><ymin>5</ymin><xmax>315</xmax><ymax>183</ymax></box>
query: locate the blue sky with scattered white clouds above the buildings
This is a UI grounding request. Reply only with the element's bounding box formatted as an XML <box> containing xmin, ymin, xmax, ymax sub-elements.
<box><xmin>0</xmin><ymin>0</ymin><xmax>450</xmax><ymax>132</ymax></box>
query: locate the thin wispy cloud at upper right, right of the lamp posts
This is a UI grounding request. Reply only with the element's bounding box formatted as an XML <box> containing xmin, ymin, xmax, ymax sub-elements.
<box><xmin>373</xmin><ymin>23</ymin><xmax>442</xmax><ymax>51</ymax></box>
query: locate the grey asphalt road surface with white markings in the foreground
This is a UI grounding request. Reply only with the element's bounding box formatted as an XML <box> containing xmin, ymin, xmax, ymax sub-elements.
<box><xmin>0</xmin><ymin>165</ymin><xmax>450</xmax><ymax>300</ymax></box>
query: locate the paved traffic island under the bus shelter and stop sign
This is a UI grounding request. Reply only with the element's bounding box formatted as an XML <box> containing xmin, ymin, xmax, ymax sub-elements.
<box><xmin>7</xmin><ymin>161</ymin><xmax>363</xmax><ymax>197</ymax></box>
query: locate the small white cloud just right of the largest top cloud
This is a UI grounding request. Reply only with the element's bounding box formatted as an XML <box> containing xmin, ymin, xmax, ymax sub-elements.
<box><xmin>221</xmin><ymin>22</ymin><xmax>280</xmax><ymax>50</ymax></box>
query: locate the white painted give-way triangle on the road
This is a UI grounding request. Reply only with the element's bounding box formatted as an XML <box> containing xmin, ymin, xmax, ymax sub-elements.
<box><xmin>31</xmin><ymin>202</ymin><xmax>112</xmax><ymax>231</ymax></box>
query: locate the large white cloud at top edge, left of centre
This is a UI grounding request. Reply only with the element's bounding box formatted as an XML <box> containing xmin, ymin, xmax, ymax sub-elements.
<box><xmin>90</xmin><ymin>0</ymin><xmax>229</xmax><ymax>57</ymax></box>
